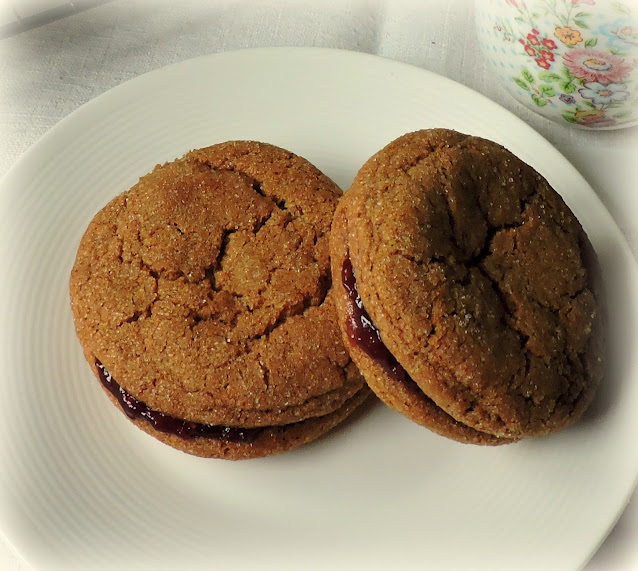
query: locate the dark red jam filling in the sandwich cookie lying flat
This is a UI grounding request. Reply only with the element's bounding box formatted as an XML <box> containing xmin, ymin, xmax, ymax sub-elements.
<box><xmin>95</xmin><ymin>359</ymin><xmax>264</xmax><ymax>444</ymax></box>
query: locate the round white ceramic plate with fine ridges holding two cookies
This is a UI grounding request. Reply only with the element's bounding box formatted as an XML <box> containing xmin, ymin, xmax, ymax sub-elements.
<box><xmin>0</xmin><ymin>48</ymin><xmax>638</xmax><ymax>570</ymax></box>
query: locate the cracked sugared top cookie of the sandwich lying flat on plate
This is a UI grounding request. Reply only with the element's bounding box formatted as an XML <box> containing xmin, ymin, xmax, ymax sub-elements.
<box><xmin>70</xmin><ymin>141</ymin><xmax>363</xmax><ymax>427</ymax></box>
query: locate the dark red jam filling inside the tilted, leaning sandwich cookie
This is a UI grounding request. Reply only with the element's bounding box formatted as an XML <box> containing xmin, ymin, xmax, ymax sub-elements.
<box><xmin>341</xmin><ymin>256</ymin><xmax>410</xmax><ymax>381</ymax></box>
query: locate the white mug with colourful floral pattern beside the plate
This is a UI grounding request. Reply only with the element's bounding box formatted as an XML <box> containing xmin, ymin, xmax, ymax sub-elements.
<box><xmin>475</xmin><ymin>0</ymin><xmax>638</xmax><ymax>129</ymax></box>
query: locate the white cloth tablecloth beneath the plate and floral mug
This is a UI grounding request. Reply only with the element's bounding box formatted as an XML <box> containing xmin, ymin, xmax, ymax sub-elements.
<box><xmin>0</xmin><ymin>0</ymin><xmax>638</xmax><ymax>571</ymax></box>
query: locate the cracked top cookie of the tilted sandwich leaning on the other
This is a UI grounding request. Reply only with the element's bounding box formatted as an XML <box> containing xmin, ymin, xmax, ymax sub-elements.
<box><xmin>346</xmin><ymin>129</ymin><xmax>603</xmax><ymax>438</ymax></box>
